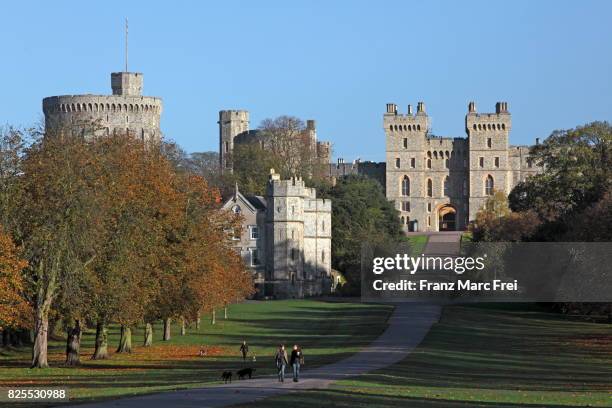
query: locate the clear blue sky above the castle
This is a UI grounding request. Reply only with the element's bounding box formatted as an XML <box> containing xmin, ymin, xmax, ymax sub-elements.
<box><xmin>0</xmin><ymin>0</ymin><xmax>612</xmax><ymax>161</ymax></box>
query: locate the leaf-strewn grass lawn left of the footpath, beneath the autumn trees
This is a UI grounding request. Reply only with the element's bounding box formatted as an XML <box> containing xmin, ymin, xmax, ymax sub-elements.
<box><xmin>0</xmin><ymin>300</ymin><xmax>392</xmax><ymax>406</ymax></box>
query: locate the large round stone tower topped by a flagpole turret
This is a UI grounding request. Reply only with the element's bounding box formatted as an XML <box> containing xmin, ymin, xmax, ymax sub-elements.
<box><xmin>43</xmin><ymin>72</ymin><xmax>162</xmax><ymax>141</ymax></box>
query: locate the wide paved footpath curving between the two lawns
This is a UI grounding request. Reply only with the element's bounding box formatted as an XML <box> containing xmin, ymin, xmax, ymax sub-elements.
<box><xmin>69</xmin><ymin>303</ymin><xmax>441</xmax><ymax>408</ymax></box>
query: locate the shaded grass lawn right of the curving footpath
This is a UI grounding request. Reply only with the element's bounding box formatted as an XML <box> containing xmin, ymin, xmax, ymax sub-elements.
<box><xmin>237</xmin><ymin>304</ymin><xmax>612</xmax><ymax>408</ymax></box>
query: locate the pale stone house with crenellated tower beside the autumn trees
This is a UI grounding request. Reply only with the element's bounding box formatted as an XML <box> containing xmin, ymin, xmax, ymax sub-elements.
<box><xmin>223</xmin><ymin>170</ymin><xmax>332</xmax><ymax>298</ymax></box>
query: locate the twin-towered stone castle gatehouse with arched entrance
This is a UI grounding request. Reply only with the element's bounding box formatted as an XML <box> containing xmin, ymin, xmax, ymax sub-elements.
<box><xmin>383</xmin><ymin>102</ymin><xmax>538</xmax><ymax>231</ymax></box>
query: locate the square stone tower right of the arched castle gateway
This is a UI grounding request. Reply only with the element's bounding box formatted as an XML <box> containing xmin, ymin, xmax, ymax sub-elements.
<box><xmin>465</xmin><ymin>102</ymin><xmax>513</xmax><ymax>220</ymax></box>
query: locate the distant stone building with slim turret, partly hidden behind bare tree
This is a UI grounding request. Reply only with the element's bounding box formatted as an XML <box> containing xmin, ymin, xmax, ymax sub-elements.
<box><xmin>218</xmin><ymin>110</ymin><xmax>331</xmax><ymax>172</ymax></box>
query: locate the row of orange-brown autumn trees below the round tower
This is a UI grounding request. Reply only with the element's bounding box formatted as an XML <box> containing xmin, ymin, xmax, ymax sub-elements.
<box><xmin>0</xmin><ymin>128</ymin><xmax>253</xmax><ymax>367</ymax></box>
